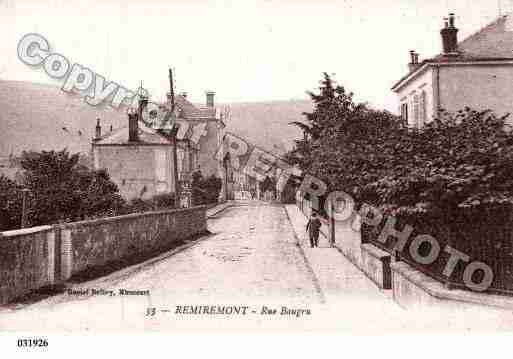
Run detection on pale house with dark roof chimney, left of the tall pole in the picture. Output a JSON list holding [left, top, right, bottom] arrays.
[[92, 113, 175, 199]]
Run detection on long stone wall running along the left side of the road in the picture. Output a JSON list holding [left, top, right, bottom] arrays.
[[0, 206, 207, 305]]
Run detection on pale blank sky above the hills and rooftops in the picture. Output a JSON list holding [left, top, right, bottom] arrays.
[[0, 0, 513, 112]]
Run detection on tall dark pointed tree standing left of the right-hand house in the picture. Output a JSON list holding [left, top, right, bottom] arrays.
[[286, 73, 404, 202]]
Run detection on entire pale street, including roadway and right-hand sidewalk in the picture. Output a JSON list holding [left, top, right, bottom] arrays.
[[0, 201, 509, 332]]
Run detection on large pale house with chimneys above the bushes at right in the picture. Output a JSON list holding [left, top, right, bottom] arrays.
[[392, 14, 513, 128]]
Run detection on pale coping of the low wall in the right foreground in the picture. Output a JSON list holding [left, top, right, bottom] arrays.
[[390, 262, 513, 310]]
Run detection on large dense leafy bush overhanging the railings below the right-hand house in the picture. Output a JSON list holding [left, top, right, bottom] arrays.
[[362, 108, 513, 221]]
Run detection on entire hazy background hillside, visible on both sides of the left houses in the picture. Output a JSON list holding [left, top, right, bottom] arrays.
[[0, 81, 312, 157]]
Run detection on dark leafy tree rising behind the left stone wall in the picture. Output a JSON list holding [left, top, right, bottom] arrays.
[[20, 150, 124, 225]]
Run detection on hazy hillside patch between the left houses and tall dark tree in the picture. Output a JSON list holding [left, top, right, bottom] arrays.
[[226, 100, 312, 155]]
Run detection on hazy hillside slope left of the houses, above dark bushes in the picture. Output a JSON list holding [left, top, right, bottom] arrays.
[[0, 81, 126, 155]]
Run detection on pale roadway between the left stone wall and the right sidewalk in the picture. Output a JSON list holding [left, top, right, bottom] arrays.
[[0, 202, 322, 330]]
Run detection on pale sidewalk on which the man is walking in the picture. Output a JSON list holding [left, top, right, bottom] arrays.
[[285, 204, 396, 307]]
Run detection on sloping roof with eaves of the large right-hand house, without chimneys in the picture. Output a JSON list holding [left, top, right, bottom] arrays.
[[392, 14, 513, 90]]
